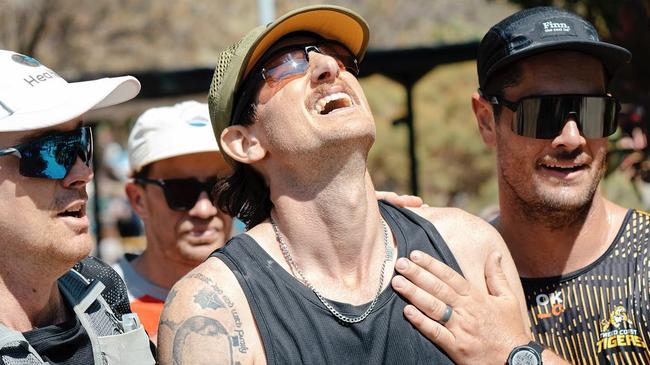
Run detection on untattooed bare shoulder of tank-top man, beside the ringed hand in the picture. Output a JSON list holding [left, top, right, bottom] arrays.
[[412, 207, 519, 290]]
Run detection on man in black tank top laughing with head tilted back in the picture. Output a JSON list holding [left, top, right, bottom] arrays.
[[159, 6, 529, 364]]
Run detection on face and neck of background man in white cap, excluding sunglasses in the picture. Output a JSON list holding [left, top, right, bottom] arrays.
[[126, 152, 232, 288]]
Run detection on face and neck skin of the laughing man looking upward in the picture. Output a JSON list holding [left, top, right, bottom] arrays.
[[238, 37, 390, 304]]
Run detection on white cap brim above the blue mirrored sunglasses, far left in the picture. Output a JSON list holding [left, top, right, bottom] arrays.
[[0, 76, 140, 132]]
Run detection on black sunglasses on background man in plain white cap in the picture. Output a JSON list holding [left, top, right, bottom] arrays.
[[134, 176, 219, 211]]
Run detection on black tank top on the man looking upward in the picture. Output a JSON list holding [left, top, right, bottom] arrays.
[[211, 202, 460, 365]]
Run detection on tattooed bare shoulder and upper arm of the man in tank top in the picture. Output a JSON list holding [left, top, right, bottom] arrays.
[[158, 258, 265, 365]]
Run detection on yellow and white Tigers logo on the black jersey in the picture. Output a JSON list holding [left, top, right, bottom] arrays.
[[598, 305, 647, 353]]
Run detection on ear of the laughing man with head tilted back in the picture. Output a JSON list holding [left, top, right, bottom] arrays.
[[221, 125, 266, 165]]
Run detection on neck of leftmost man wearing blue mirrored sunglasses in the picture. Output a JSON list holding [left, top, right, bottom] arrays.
[[0, 264, 69, 332]]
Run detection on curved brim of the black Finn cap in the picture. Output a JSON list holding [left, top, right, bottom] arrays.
[[484, 42, 632, 83]]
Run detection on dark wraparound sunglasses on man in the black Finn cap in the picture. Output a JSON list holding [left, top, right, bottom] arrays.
[[485, 95, 621, 139]]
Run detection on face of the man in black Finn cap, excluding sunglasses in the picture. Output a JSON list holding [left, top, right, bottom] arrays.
[[496, 54, 607, 219]]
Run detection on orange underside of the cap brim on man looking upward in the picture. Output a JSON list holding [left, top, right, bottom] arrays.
[[242, 5, 369, 78]]
